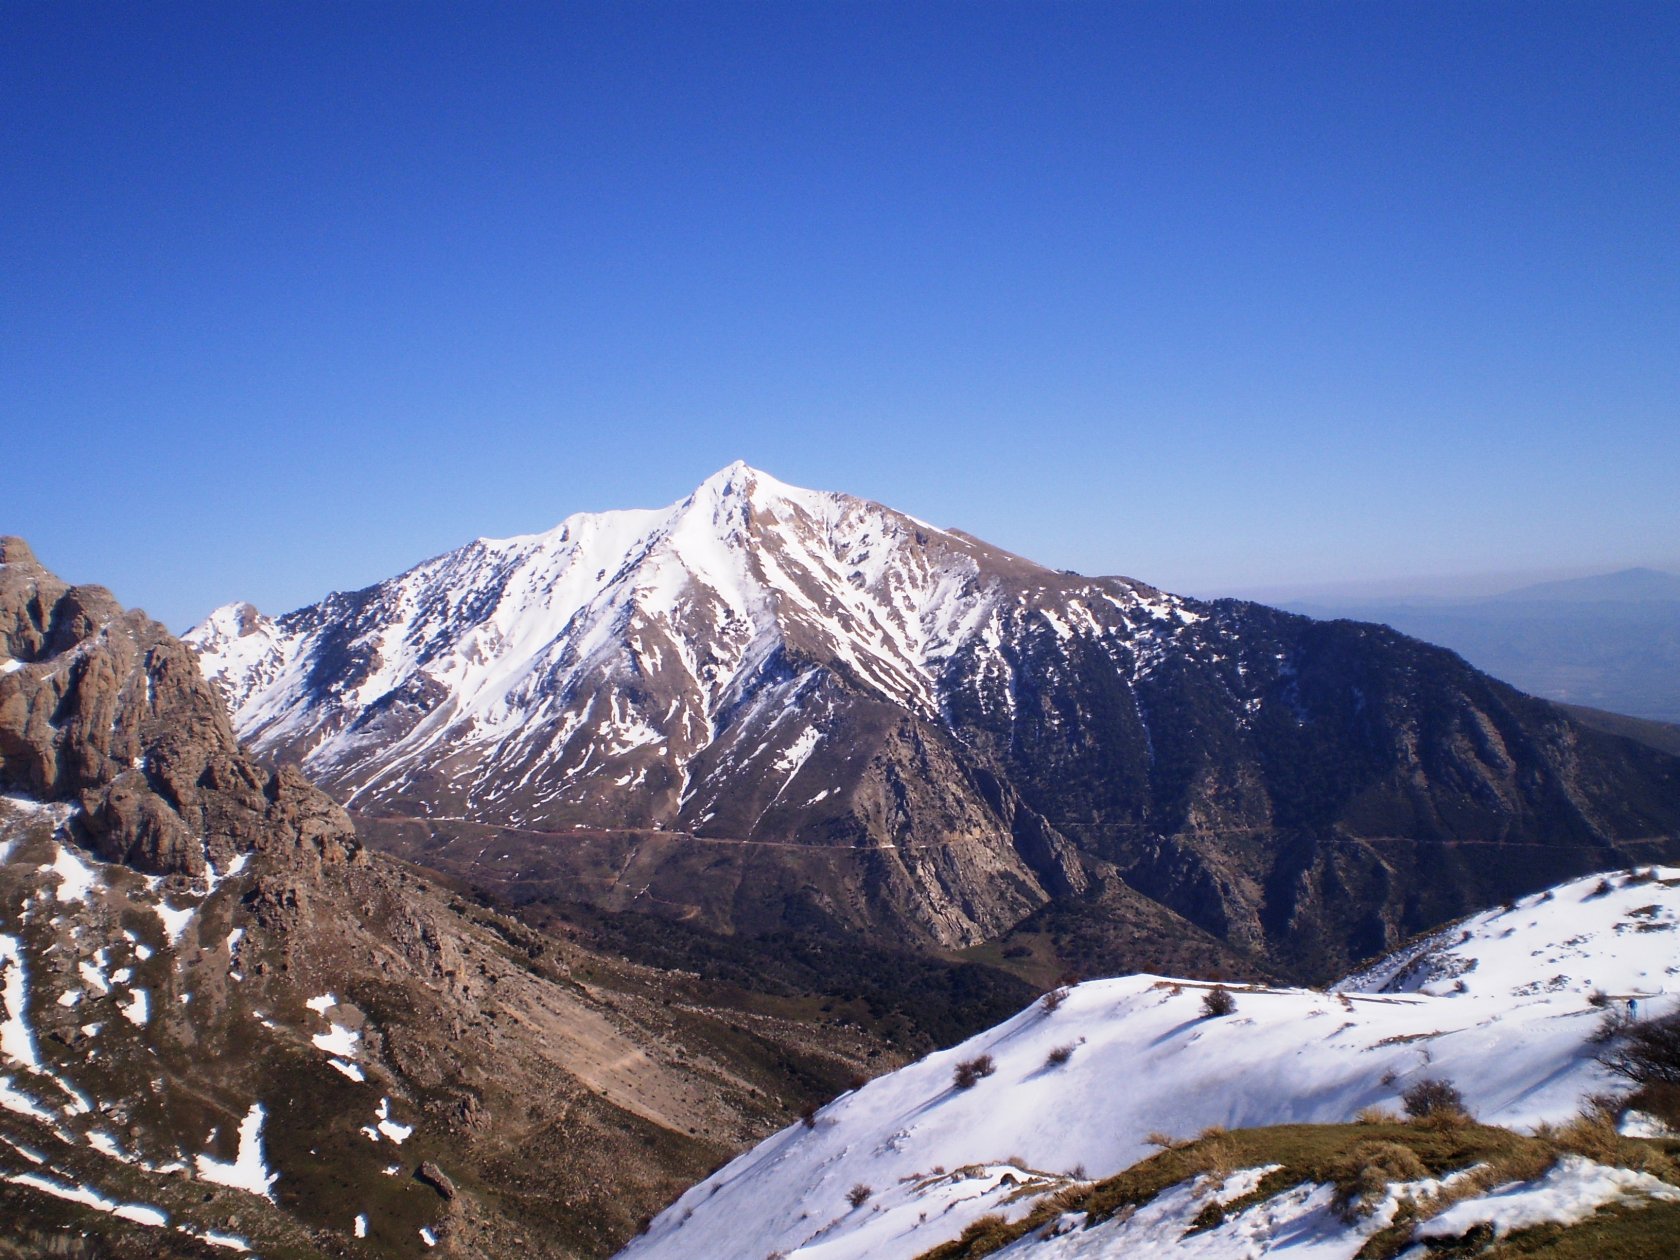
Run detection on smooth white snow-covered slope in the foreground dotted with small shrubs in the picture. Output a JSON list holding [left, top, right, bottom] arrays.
[[623, 867, 1680, 1260]]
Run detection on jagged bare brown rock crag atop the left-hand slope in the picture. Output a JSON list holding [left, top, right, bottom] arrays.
[[0, 538, 360, 879]]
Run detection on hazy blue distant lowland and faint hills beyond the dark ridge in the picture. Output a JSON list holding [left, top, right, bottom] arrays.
[[1287, 568, 1680, 722]]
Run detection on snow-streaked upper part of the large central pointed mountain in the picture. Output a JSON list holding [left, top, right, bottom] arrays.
[[188, 462, 1102, 850]]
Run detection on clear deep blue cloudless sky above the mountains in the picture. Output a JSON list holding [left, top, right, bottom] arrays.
[[0, 0, 1680, 628]]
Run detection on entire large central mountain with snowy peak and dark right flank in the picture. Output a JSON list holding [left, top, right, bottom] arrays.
[[190, 465, 1680, 976]]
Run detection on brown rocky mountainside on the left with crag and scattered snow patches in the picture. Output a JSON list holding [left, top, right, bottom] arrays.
[[0, 539, 897, 1258]]
